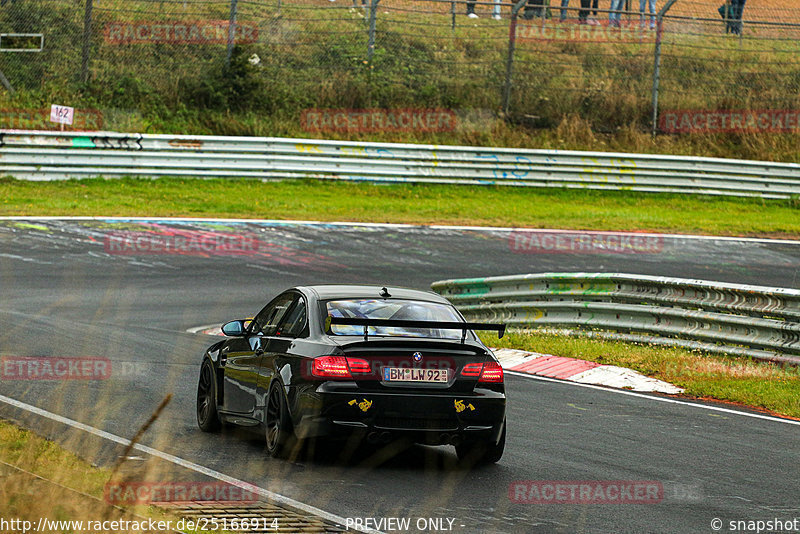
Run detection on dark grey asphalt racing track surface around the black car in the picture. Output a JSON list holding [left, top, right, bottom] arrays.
[[0, 220, 800, 533]]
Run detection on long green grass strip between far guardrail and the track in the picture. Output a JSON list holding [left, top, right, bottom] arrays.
[[0, 178, 800, 236]]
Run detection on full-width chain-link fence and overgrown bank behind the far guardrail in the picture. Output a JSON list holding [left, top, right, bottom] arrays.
[[0, 0, 800, 133]]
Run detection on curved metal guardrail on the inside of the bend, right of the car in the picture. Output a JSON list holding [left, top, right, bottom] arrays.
[[431, 273, 800, 365]]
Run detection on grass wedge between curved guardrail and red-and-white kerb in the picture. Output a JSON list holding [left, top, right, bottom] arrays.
[[481, 332, 800, 418]]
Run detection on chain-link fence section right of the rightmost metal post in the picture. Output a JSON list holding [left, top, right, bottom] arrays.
[[656, 0, 800, 136]]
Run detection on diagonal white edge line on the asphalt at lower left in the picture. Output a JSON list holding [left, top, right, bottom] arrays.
[[0, 395, 383, 534]]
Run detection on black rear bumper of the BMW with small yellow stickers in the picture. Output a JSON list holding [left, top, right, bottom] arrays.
[[294, 383, 506, 444]]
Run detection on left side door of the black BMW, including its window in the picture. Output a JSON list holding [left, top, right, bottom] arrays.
[[223, 293, 295, 414]]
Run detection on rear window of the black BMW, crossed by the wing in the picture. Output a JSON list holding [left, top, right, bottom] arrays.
[[326, 299, 462, 339]]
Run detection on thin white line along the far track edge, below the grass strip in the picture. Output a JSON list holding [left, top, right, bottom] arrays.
[[0, 215, 800, 245]]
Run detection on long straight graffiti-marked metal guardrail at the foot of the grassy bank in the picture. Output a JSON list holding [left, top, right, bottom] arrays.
[[0, 130, 800, 198]]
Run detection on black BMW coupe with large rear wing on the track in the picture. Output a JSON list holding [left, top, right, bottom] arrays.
[[197, 285, 506, 463]]
